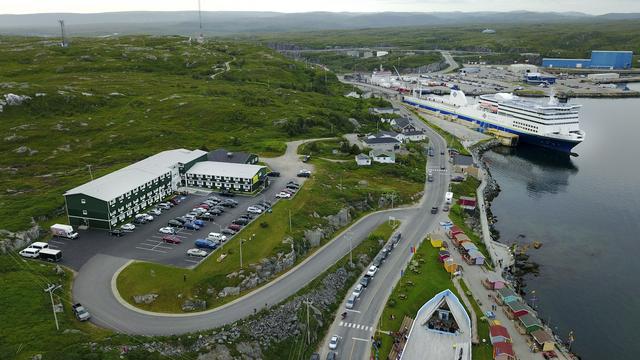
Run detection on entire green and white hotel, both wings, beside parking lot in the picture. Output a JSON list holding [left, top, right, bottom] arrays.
[[64, 149, 267, 229]]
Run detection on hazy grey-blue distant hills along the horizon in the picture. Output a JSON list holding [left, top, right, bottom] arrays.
[[0, 11, 640, 36]]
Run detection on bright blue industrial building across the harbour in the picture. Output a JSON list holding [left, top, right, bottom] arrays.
[[542, 50, 633, 70]]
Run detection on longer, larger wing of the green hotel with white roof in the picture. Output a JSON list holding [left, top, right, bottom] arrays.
[[64, 149, 207, 229]]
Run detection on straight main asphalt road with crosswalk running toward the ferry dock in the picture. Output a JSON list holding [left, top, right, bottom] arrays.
[[320, 97, 449, 360]]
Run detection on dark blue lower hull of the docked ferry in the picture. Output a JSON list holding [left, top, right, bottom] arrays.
[[403, 98, 580, 153]]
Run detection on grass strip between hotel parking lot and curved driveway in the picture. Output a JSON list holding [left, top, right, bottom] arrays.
[[117, 154, 424, 312]]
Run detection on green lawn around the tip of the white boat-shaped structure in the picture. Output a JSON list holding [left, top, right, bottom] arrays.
[[372, 240, 492, 360]]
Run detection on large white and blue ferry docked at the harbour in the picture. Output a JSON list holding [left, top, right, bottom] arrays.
[[403, 90, 585, 152]]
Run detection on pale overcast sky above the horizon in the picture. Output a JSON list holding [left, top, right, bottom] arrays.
[[0, 0, 640, 14]]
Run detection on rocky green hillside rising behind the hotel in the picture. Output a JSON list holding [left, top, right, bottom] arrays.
[[0, 36, 390, 231]]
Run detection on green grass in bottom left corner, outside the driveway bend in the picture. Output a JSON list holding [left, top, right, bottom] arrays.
[[0, 253, 121, 360]]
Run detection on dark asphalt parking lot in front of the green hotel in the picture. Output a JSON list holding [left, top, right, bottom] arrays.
[[49, 172, 303, 270]]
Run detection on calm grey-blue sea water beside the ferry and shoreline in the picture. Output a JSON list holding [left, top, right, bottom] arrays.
[[484, 90, 640, 360]]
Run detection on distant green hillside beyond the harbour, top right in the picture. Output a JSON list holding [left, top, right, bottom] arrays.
[[261, 20, 640, 66]]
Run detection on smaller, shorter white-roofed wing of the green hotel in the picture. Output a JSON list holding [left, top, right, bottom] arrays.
[[185, 161, 267, 193]]
